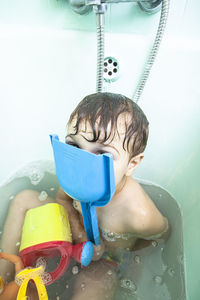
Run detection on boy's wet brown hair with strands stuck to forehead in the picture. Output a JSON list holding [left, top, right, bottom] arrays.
[[68, 93, 149, 158]]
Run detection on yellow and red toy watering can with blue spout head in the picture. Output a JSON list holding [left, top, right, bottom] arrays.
[[19, 203, 93, 285]]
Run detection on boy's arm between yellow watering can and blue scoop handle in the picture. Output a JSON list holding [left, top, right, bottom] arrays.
[[56, 187, 87, 244]]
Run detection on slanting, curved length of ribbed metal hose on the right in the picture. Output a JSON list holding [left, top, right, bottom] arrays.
[[133, 0, 170, 103]]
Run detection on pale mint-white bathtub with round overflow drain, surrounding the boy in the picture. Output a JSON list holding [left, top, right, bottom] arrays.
[[0, 0, 200, 300]]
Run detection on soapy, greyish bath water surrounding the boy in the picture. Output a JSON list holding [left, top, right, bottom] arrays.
[[0, 161, 186, 300]]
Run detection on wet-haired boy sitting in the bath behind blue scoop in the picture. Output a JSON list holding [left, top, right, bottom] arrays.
[[2, 93, 168, 300]]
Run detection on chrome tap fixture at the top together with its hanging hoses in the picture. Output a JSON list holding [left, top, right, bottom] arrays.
[[70, 0, 170, 98]]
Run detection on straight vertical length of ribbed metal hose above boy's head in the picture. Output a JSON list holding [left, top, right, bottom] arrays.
[[95, 4, 105, 93]]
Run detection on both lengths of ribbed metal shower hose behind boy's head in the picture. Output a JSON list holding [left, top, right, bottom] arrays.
[[96, 0, 170, 103]]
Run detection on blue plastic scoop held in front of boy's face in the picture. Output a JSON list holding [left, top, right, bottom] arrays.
[[50, 135, 115, 245]]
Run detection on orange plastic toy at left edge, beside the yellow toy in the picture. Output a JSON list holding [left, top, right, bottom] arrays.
[[0, 252, 24, 300]]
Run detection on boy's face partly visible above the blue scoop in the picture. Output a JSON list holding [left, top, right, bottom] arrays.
[[66, 115, 142, 192]]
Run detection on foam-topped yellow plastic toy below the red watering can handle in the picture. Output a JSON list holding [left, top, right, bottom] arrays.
[[15, 266, 48, 300]]
